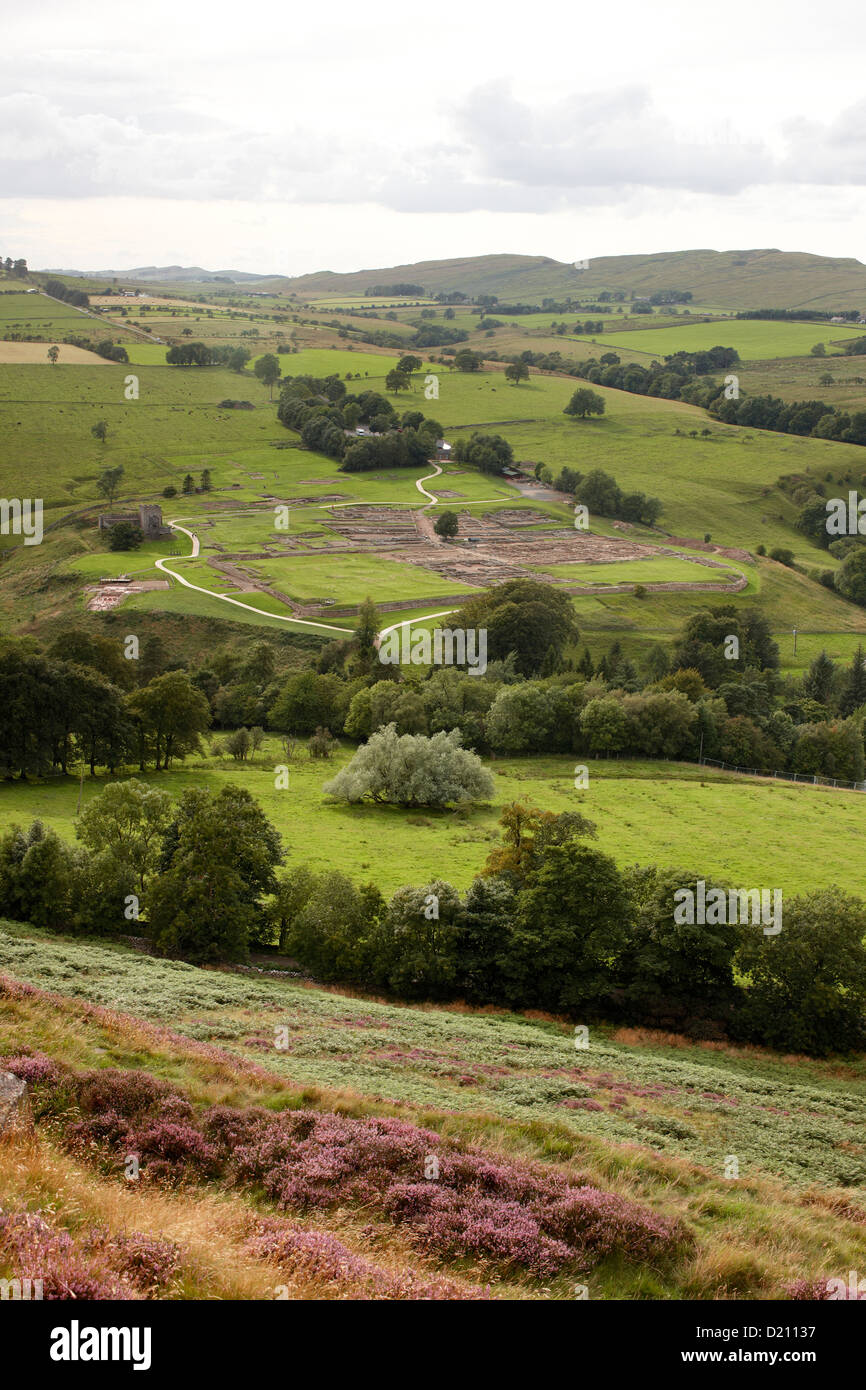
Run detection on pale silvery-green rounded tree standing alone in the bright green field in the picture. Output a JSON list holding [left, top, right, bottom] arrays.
[[322, 724, 493, 806]]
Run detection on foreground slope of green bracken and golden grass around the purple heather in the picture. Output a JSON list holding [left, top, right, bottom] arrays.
[[0, 924, 866, 1298]]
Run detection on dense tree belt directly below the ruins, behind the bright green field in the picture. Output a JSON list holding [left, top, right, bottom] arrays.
[[0, 580, 866, 801]]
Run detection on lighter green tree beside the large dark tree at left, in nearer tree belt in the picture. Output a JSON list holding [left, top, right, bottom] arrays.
[[75, 777, 172, 894]]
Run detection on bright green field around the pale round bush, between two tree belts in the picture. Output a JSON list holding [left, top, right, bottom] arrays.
[[0, 745, 866, 895]]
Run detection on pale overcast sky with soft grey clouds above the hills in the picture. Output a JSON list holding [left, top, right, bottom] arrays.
[[0, 0, 866, 275]]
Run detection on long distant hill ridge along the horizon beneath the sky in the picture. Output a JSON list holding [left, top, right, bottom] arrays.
[[38, 250, 866, 309]]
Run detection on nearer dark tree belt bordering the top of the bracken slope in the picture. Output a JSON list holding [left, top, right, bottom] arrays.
[[0, 781, 866, 1056]]
